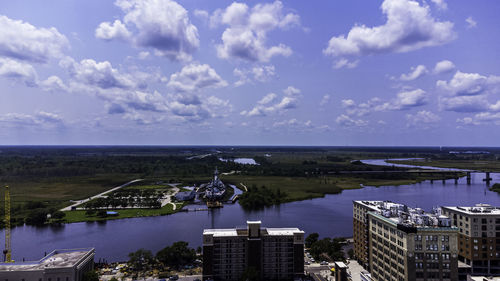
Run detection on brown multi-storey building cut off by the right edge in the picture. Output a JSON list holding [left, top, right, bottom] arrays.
[[442, 204, 500, 276]]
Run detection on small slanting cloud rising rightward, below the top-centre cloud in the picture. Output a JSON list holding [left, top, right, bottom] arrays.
[[240, 86, 300, 117]]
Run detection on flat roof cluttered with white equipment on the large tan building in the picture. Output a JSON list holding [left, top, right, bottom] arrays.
[[356, 201, 451, 228]]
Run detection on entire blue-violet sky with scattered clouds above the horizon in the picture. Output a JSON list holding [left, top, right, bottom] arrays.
[[0, 0, 500, 146]]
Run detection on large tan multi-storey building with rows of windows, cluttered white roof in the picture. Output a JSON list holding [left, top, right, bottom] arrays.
[[353, 201, 458, 281]]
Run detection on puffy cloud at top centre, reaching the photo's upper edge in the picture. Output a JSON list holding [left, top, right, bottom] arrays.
[[210, 1, 300, 62]]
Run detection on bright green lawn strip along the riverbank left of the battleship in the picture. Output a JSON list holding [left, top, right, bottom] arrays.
[[63, 203, 184, 223]]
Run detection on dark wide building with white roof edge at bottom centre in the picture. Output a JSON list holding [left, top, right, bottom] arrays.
[[203, 221, 304, 281]]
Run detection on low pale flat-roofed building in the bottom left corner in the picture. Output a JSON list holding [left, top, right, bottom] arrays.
[[0, 248, 95, 281]]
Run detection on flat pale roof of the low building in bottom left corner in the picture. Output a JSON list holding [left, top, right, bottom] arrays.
[[0, 248, 95, 271]]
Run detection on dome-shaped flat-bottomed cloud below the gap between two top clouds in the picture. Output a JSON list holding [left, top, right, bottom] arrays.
[[168, 63, 227, 92]]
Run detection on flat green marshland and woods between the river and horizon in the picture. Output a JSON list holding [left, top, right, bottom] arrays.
[[0, 146, 500, 224]]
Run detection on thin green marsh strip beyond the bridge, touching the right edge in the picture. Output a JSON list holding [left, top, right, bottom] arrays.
[[388, 160, 500, 172]]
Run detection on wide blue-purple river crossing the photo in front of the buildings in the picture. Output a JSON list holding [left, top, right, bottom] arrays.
[[0, 173, 500, 261]]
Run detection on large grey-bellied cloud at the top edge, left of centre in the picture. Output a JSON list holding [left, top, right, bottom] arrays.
[[95, 0, 199, 60]]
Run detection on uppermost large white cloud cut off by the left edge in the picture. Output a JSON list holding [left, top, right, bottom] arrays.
[[0, 15, 69, 63]]
